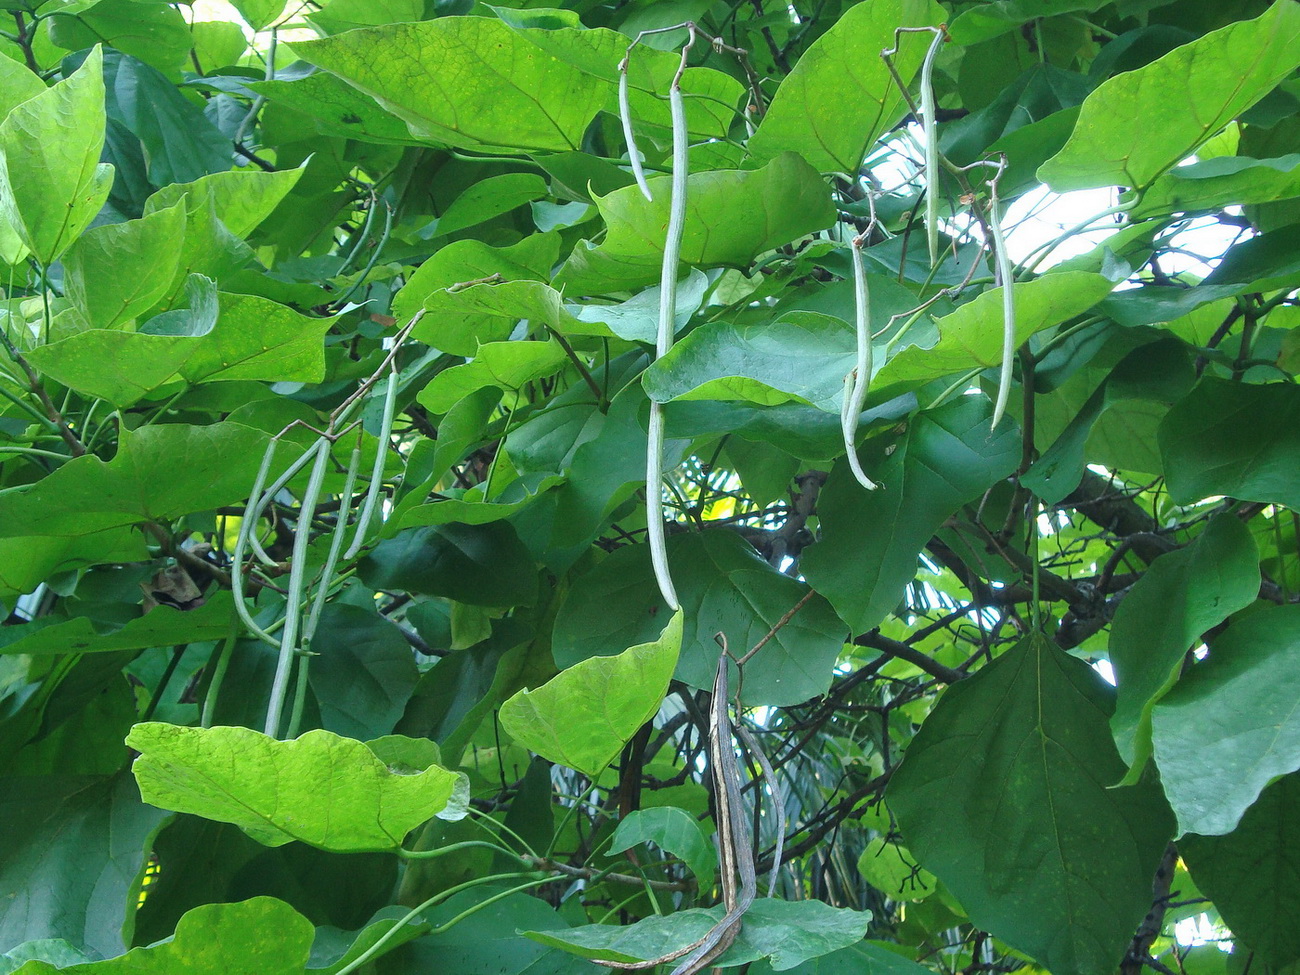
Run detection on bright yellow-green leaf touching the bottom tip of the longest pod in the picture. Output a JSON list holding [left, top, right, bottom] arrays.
[[501, 611, 683, 779]]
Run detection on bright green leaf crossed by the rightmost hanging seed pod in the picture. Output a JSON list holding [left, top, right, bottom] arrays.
[[872, 270, 1115, 397]]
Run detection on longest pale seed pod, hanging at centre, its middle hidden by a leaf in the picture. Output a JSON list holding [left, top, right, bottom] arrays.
[[646, 70, 689, 611]]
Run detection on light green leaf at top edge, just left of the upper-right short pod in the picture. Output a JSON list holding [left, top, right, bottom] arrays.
[[749, 0, 946, 173]]
